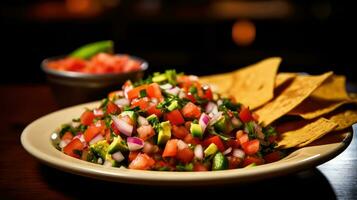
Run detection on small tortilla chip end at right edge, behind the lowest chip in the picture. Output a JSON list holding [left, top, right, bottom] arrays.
[[329, 110, 357, 130]]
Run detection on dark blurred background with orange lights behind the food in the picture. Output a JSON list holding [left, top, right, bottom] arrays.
[[0, 0, 356, 84]]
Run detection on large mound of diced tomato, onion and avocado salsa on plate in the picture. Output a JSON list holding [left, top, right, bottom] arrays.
[[57, 70, 283, 171]]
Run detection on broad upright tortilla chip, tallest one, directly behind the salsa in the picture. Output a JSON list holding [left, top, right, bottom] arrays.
[[230, 57, 281, 109]]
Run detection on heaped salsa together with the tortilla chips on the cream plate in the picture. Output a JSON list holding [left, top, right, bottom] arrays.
[[51, 58, 357, 171]]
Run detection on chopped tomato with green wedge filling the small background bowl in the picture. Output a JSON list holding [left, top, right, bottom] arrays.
[[47, 41, 142, 74]]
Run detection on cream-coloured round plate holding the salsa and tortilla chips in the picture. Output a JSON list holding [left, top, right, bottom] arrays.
[[21, 102, 353, 185]]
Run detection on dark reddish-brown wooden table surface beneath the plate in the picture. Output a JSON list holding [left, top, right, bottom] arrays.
[[0, 85, 357, 200]]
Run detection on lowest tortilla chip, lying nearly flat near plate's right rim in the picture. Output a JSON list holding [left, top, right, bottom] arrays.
[[277, 118, 337, 149]]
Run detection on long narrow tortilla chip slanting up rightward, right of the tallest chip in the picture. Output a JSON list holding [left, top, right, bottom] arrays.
[[256, 72, 333, 125]]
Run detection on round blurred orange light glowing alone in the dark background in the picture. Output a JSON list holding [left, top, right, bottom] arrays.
[[232, 20, 256, 46]]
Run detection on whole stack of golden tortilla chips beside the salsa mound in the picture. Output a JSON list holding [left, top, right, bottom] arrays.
[[200, 57, 357, 148]]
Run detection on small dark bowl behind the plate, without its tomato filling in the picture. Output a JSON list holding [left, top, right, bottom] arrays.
[[41, 56, 149, 107]]
